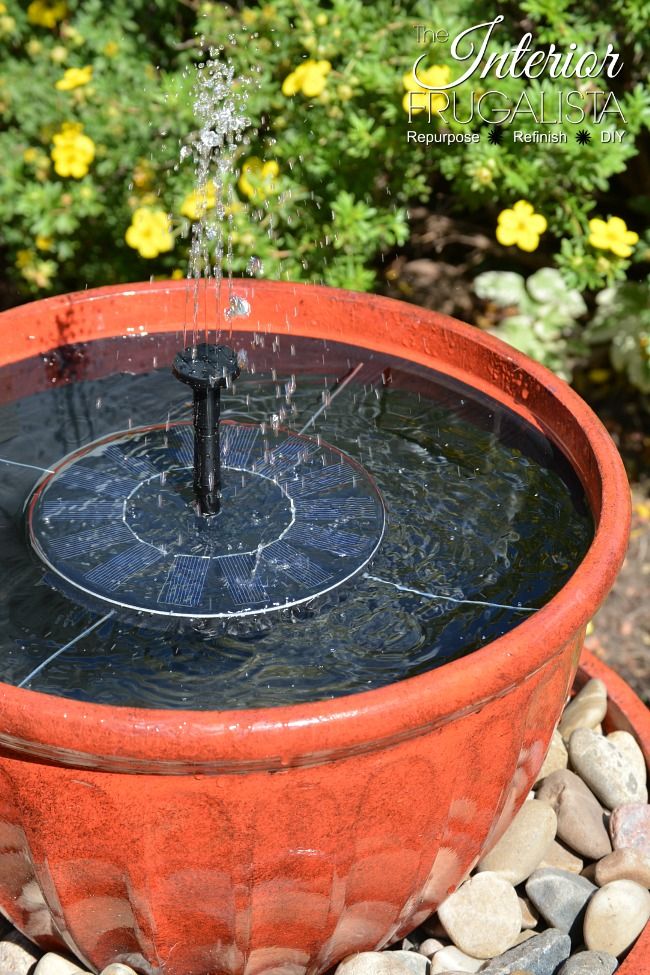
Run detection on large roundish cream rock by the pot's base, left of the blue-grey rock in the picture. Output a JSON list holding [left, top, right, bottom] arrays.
[[438, 871, 521, 958]]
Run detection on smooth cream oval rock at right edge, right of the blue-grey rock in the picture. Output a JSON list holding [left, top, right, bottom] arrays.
[[583, 880, 650, 958]]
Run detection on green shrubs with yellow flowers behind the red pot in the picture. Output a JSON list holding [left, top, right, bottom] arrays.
[[0, 0, 650, 400]]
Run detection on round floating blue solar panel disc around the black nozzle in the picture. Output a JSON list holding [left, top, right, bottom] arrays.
[[27, 420, 385, 619]]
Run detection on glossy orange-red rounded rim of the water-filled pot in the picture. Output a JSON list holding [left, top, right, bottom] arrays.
[[0, 281, 630, 774]]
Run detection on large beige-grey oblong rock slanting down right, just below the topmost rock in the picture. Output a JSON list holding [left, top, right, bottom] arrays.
[[569, 728, 648, 809]]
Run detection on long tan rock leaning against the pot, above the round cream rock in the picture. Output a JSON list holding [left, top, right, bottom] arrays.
[[476, 799, 557, 886]]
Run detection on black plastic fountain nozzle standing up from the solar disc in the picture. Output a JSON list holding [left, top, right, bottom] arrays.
[[172, 342, 240, 515]]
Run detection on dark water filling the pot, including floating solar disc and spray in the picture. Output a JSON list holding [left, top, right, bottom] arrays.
[[0, 57, 592, 709]]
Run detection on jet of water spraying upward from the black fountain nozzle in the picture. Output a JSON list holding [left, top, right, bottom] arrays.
[[180, 49, 250, 345]]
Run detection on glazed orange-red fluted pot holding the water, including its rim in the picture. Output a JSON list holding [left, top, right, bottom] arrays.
[[0, 282, 629, 975]]
